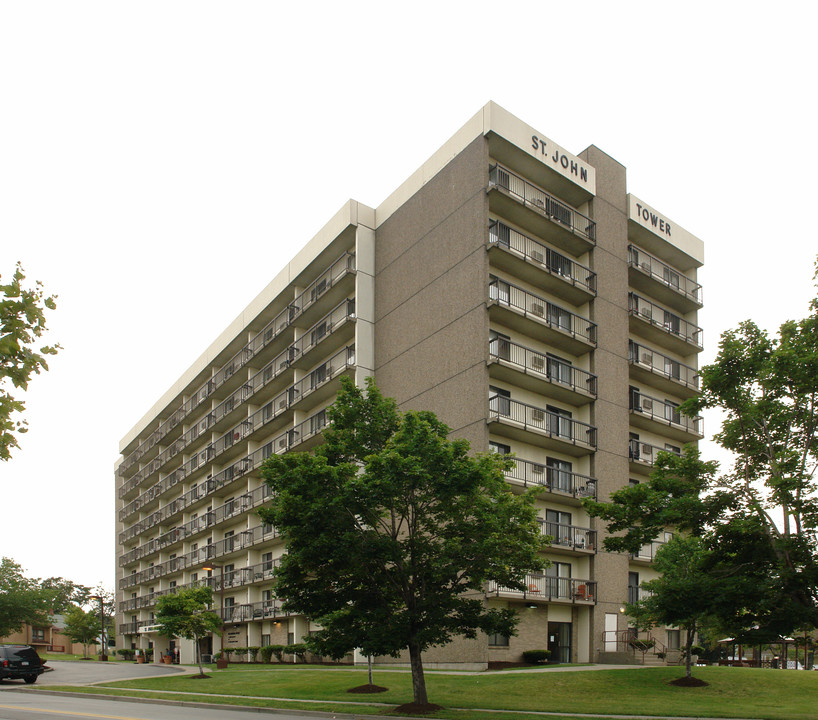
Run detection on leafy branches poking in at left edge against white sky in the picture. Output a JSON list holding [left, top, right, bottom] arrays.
[[0, 263, 60, 460]]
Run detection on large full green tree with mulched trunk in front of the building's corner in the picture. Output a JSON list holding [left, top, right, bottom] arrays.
[[260, 377, 543, 707]]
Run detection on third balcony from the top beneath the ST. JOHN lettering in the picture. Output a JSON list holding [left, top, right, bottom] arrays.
[[488, 279, 596, 355]]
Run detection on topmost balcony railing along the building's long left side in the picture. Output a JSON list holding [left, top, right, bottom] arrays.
[[117, 252, 355, 484]]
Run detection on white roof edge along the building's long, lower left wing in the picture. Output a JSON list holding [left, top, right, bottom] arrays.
[[119, 200, 375, 452]]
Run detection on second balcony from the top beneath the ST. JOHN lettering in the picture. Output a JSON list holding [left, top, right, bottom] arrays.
[[489, 220, 596, 305]]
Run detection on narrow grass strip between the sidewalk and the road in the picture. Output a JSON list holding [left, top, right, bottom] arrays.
[[35, 685, 636, 720]]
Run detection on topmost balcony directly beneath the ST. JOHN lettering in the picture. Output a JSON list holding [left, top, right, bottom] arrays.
[[488, 165, 596, 256]]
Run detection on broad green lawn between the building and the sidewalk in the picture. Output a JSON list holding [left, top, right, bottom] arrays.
[[43, 665, 818, 720]]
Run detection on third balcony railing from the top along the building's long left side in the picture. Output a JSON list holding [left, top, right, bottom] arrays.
[[119, 346, 355, 520]]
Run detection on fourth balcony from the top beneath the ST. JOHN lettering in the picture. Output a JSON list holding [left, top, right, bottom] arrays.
[[489, 338, 596, 405]]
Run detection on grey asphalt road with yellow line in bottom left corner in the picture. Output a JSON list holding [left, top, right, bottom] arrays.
[[0, 684, 342, 720]]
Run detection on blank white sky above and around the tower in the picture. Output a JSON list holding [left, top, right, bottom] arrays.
[[0, 0, 818, 587]]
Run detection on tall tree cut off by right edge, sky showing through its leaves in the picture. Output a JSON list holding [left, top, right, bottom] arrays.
[[682, 263, 818, 635]]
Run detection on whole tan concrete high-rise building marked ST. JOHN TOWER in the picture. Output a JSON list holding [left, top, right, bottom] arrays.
[[115, 103, 703, 668]]
